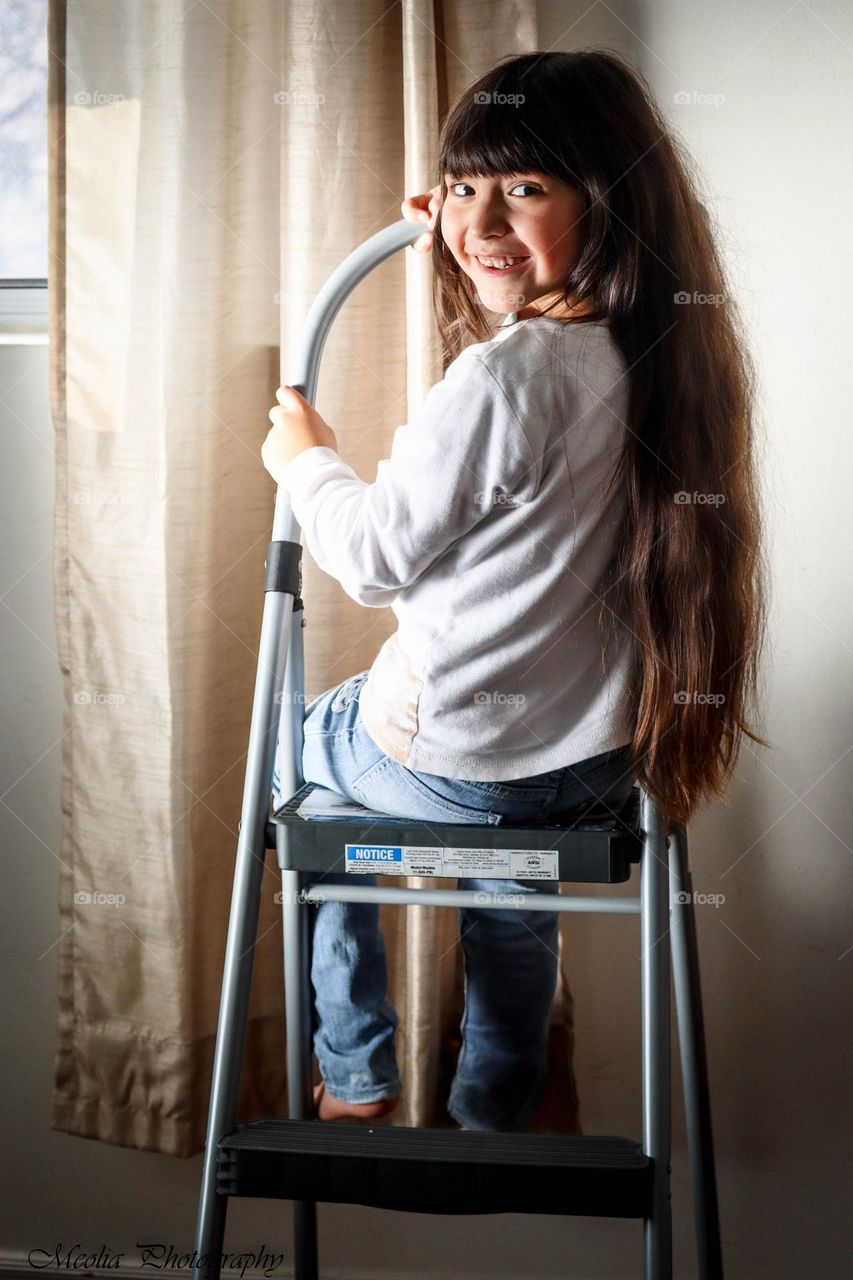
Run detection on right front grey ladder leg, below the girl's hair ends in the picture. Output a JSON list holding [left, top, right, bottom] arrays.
[[640, 791, 672, 1280]]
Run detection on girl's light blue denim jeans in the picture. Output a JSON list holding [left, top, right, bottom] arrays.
[[273, 671, 634, 1132]]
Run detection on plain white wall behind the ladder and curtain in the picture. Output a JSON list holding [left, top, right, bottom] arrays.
[[0, 0, 853, 1280]]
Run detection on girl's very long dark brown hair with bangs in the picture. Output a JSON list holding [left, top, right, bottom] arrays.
[[433, 49, 771, 824]]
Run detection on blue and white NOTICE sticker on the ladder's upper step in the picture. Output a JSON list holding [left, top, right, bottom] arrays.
[[345, 845, 558, 879]]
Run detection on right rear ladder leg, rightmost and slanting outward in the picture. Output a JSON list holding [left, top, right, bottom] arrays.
[[670, 826, 722, 1280]]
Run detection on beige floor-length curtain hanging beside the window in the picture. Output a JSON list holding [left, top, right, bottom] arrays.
[[49, 0, 576, 1156]]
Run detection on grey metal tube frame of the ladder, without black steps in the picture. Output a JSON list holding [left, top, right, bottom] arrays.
[[193, 220, 722, 1280]]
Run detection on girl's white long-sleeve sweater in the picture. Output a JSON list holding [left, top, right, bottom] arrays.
[[280, 316, 634, 781]]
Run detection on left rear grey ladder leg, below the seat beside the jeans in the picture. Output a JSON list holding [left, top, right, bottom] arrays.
[[282, 870, 318, 1280]]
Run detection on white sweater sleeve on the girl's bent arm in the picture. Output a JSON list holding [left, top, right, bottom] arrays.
[[280, 352, 538, 608]]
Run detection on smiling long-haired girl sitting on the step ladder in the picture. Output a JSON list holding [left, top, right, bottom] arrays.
[[263, 50, 768, 1130]]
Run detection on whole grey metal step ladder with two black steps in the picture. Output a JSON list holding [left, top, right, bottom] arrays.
[[193, 221, 722, 1280]]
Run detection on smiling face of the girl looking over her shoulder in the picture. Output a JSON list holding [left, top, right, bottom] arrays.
[[441, 172, 584, 316]]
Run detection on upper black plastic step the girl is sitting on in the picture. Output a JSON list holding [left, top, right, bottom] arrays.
[[265, 782, 642, 884]]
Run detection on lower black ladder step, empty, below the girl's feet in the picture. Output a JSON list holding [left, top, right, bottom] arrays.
[[216, 1117, 653, 1217]]
